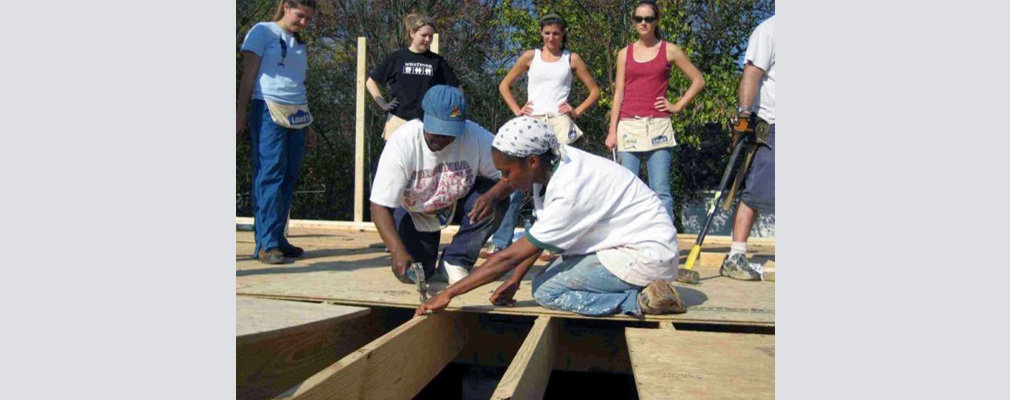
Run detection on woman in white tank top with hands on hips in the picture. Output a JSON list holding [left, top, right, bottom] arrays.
[[498, 13, 600, 144]]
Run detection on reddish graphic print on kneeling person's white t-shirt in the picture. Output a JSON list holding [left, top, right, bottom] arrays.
[[403, 161, 477, 213]]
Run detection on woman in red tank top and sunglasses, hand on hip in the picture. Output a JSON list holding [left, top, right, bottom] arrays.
[[606, 0, 705, 219]]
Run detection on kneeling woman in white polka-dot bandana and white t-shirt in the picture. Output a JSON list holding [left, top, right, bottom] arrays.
[[416, 116, 686, 315]]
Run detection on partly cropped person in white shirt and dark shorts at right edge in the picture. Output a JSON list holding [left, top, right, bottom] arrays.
[[719, 15, 775, 281]]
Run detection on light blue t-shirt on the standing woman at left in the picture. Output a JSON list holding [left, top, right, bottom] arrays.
[[242, 22, 308, 104]]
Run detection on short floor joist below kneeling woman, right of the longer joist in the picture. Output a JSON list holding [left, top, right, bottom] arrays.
[[491, 315, 561, 399]]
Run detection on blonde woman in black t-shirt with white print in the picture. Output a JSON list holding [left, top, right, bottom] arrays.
[[365, 13, 460, 140]]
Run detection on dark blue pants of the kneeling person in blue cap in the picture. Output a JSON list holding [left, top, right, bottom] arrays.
[[393, 177, 508, 279]]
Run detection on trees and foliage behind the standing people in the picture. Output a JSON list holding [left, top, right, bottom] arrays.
[[235, 0, 775, 231]]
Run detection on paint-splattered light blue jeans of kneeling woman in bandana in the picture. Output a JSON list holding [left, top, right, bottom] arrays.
[[533, 254, 642, 315]]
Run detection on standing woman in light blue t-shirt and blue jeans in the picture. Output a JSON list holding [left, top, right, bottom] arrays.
[[235, 0, 316, 264]]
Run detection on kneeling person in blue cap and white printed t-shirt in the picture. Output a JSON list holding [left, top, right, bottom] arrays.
[[370, 85, 512, 284]]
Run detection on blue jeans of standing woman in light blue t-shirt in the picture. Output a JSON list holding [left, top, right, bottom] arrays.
[[249, 100, 305, 259]]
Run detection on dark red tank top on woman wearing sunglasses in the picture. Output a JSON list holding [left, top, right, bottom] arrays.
[[620, 40, 670, 118]]
